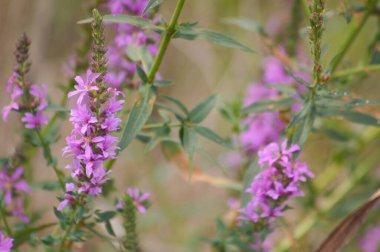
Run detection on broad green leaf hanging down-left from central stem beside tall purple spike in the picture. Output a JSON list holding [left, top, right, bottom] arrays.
[[119, 86, 156, 150]]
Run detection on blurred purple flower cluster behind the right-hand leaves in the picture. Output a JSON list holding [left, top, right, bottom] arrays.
[[240, 54, 307, 154]]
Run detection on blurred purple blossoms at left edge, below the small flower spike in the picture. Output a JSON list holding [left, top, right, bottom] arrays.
[[0, 167, 30, 222]]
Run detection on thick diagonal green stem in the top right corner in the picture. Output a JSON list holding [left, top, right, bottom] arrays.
[[331, 0, 377, 74]]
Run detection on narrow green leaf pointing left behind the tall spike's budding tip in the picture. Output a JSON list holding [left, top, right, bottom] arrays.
[[78, 15, 165, 32]]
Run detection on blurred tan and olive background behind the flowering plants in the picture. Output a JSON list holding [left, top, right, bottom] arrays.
[[0, 0, 380, 252]]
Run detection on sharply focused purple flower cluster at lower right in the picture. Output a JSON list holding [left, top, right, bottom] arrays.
[[239, 140, 314, 224]]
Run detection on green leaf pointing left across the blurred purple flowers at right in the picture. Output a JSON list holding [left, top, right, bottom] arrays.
[[242, 97, 295, 116]]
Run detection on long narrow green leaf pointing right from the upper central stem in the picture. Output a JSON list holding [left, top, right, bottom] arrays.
[[173, 26, 254, 53]]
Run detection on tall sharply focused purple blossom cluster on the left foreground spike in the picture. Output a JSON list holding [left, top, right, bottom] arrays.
[[57, 70, 124, 210]]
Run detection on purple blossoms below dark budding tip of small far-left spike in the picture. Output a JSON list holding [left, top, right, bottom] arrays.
[[2, 71, 48, 129]]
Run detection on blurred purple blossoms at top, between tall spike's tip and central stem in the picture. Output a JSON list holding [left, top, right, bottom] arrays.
[[107, 0, 159, 89]]
